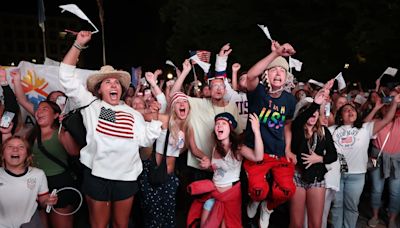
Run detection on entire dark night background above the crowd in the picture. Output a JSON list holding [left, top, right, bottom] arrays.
[[1, 0, 400, 87]]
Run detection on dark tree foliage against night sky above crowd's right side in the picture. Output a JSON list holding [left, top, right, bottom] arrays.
[[160, 0, 400, 87]]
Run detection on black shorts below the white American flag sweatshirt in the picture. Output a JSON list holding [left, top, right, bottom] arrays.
[[82, 167, 139, 201]]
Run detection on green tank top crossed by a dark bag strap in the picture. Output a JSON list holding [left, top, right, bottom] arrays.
[[32, 130, 68, 176]]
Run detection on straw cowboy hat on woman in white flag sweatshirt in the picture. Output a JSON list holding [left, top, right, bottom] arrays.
[[86, 65, 131, 93]]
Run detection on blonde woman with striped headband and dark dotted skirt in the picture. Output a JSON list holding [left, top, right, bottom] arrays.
[[140, 89, 190, 227]]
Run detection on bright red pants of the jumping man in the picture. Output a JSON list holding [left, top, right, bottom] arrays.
[[243, 154, 296, 210]]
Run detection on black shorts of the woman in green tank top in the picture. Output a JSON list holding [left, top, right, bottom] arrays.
[[47, 171, 79, 208]]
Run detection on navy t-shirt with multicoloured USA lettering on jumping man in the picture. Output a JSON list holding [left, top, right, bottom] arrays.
[[245, 84, 296, 157]]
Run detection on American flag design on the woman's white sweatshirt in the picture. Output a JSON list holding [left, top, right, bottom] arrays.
[[96, 107, 135, 139]]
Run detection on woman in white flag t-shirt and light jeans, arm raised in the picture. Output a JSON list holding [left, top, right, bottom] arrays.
[[329, 91, 400, 228]]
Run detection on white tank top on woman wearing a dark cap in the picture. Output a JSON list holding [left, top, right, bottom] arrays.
[[211, 151, 242, 187]]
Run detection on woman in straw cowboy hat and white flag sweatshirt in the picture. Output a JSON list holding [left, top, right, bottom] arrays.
[[60, 31, 166, 227]]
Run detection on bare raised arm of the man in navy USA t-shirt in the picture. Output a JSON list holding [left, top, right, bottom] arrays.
[[247, 41, 296, 91]]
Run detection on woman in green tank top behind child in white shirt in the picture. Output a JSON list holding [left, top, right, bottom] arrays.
[[28, 100, 79, 228]]
